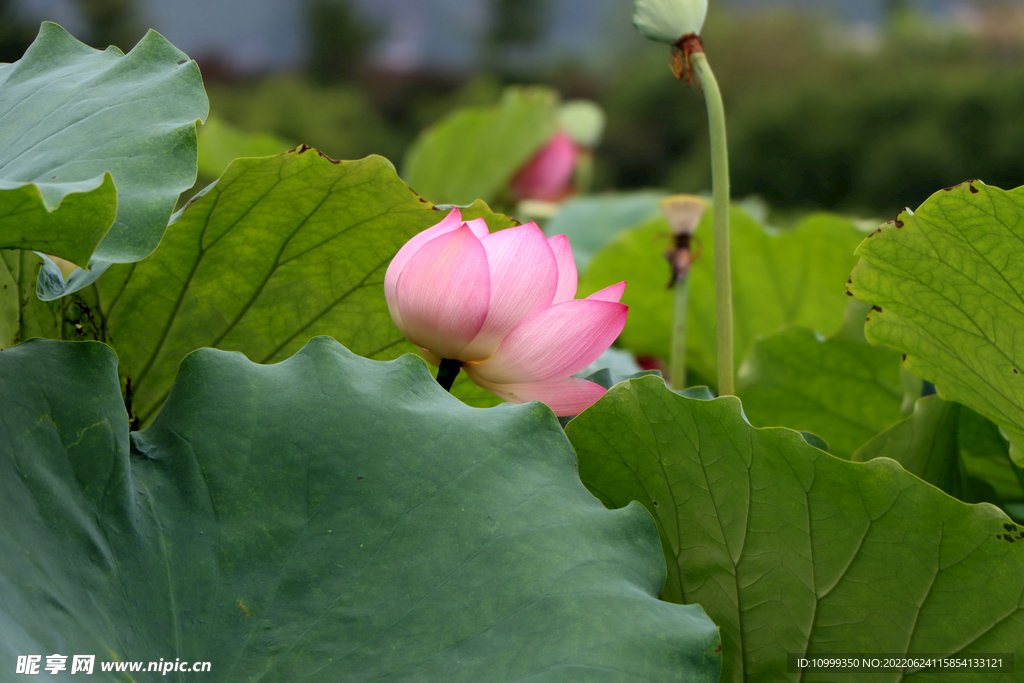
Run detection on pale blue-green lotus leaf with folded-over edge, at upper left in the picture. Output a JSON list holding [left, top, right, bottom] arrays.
[[0, 23, 209, 290]]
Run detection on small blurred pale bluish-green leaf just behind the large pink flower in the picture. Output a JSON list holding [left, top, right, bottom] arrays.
[[544, 189, 668, 272]]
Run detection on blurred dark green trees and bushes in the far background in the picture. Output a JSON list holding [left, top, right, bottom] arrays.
[[0, 0, 1024, 217]]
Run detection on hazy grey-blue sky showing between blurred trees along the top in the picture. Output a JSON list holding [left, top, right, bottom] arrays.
[[19, 0, 955, 72]]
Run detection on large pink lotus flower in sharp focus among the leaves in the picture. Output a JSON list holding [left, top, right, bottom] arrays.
[[384, 209, 627, 415]]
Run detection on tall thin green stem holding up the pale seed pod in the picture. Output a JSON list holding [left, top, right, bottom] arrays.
[[689, 52, 736, 396]]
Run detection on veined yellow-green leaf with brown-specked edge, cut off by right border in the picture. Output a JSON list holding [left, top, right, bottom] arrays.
[[849, 180, 1024, 466]]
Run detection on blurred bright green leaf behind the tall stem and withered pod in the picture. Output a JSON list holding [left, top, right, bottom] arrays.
[[580, 206, 863, 381]]
